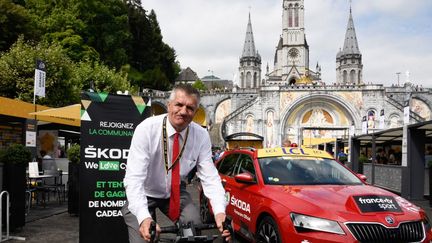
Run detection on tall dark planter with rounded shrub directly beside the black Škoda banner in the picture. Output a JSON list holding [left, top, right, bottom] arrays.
[[67, 144, 81, 215]]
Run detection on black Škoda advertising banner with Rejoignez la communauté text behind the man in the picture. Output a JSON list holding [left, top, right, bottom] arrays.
[[79, 92, 151, 243]]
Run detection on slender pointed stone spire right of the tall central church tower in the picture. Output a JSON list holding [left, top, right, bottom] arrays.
[[336, 6, 363, 84]]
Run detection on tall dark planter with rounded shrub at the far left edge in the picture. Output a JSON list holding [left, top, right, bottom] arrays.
[[0, 144, 31, 231]]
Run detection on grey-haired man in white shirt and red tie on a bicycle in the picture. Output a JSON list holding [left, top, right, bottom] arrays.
[[122, 85, 229, 243]]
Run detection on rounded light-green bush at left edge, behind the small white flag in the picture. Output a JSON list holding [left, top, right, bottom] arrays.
[[0, 38, 80, 106]]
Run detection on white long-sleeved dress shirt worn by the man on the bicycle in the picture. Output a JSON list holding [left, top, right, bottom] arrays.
[[124, 114, 226, 224]]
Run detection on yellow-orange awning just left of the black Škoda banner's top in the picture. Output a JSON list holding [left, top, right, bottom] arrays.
[[29, 104, 81, 127]]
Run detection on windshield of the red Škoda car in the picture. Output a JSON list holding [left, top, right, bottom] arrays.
[[258, 157, 362, 185]]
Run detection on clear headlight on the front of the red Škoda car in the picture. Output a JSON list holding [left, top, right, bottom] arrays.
[[291, 213, 345, 235]]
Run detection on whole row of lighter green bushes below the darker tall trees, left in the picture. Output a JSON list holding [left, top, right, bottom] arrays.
[[0, 38, 129, 107]]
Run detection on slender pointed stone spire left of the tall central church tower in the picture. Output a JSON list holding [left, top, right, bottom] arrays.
[[239, 13, 261, 88]]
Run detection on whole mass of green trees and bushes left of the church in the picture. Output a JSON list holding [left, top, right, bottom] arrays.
[[0, 0, 180, 98]]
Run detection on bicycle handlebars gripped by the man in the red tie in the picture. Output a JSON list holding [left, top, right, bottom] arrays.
[[150, 217, 234, 243]]
